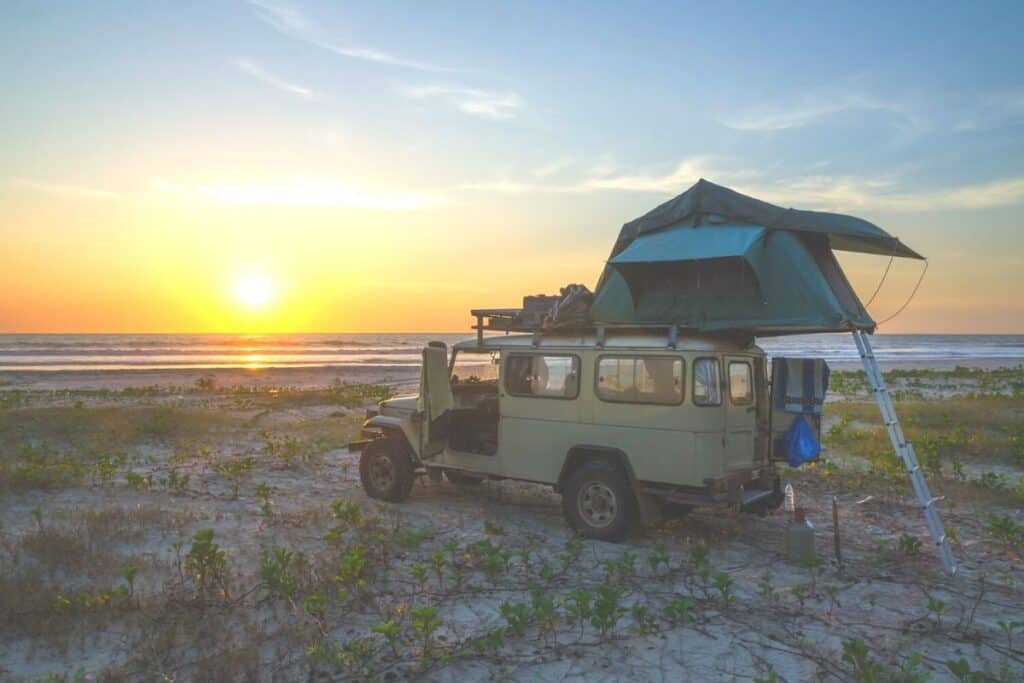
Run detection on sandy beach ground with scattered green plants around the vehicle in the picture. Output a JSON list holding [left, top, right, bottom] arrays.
[[0, 365, 1024, 681]]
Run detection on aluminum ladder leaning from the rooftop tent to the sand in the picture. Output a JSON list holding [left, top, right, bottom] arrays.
[[853, 330, 956, 577]]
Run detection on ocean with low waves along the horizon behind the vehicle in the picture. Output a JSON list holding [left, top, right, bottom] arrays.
[[0, 332, 1024, 373]]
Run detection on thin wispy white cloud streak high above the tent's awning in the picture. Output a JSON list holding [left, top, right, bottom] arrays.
[[722, 93, 923, 131]]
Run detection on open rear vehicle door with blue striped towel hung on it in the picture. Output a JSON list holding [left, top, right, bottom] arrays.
[[768, 357, 829, 461]]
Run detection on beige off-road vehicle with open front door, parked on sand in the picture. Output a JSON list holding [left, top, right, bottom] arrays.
[[351, 330, 817, 541]]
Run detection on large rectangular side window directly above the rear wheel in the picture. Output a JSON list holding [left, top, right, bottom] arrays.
[[597, 355, 683, 405]]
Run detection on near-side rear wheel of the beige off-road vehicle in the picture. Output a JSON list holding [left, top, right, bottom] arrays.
[[562, 461, 638, 543]]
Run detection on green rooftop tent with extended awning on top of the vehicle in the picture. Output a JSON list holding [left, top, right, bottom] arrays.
[[590, 179, 924, 336]]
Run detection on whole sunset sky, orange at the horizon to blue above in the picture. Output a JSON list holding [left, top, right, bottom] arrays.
[[0, 0, 1024, 333]]
